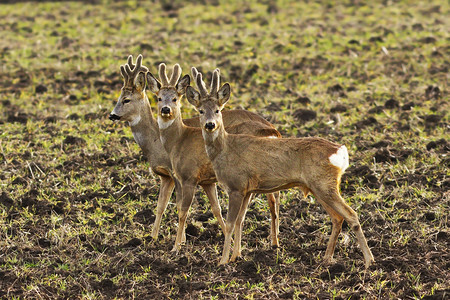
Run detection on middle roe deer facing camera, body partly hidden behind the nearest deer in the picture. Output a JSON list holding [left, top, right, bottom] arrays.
[[147, 64, 280, 251]]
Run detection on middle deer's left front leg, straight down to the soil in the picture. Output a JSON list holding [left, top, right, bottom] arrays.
[[172, 183, 196, 252]]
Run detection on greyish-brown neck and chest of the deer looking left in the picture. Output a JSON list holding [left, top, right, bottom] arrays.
[[130, 96, 170, 168]]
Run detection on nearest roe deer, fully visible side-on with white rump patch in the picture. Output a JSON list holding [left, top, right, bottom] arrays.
[[186, 70, 374, 268]]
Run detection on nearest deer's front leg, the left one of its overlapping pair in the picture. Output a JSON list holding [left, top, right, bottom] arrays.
[[219, 191, 244, 265]]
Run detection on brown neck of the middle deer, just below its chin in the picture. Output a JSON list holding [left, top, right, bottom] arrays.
[[158, 112, 186, 153]]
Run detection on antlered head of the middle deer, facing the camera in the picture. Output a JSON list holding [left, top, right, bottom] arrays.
[[147, 63, 190, 123]]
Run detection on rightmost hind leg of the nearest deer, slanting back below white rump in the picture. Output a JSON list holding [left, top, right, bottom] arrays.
[[313, 189, 375, 269]]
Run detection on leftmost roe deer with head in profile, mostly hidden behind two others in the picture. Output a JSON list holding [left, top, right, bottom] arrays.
[[109, 55, 280, 250]]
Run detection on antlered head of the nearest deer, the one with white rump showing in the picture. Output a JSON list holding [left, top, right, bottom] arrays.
[[186, 68, 231, 132]]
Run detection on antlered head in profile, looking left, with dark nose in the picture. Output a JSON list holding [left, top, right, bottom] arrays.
[[109, 54, 148, 125]]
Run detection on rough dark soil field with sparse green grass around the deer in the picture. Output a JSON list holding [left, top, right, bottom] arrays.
[[0, 0, 450, 299]]
